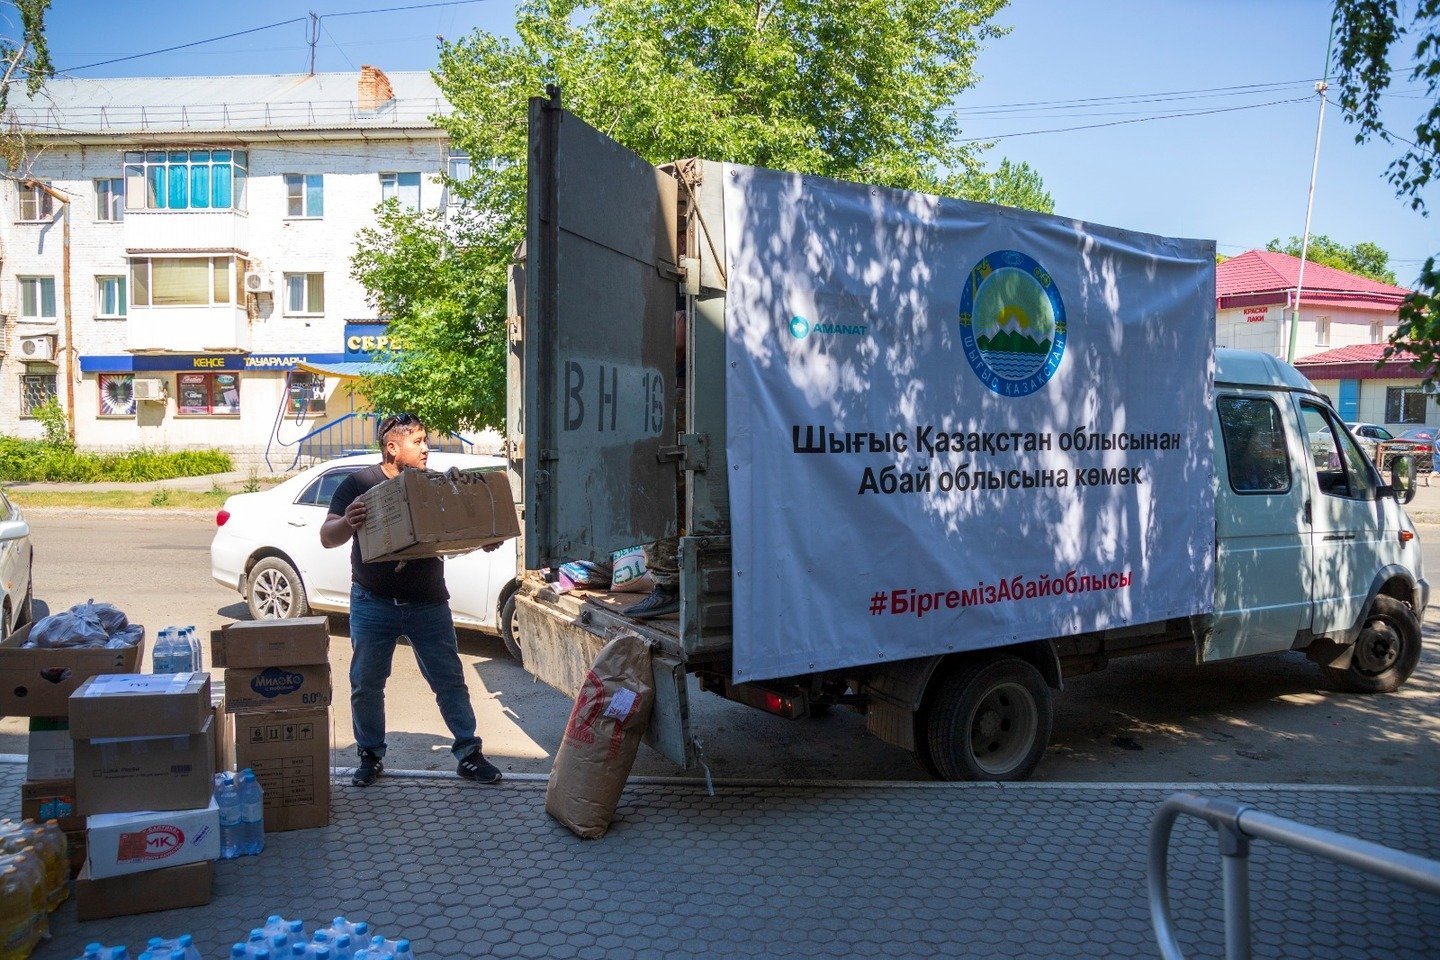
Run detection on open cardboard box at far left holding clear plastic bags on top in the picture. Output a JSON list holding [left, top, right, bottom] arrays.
[[0, 623, 145, 717]]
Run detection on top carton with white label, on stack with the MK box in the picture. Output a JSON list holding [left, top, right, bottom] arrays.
[[71, 674, 210, 740]]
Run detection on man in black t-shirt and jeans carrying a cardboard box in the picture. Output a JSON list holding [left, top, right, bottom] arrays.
[[320, 413, 501, 787]]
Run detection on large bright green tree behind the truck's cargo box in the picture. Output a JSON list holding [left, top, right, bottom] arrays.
[[353, 0, 1053, 427]]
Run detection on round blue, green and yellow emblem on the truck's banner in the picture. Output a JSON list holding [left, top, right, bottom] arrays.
[[959, 250, 1066, 397]]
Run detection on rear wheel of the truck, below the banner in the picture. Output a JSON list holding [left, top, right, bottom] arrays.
[[917, 656, 1054, 783]]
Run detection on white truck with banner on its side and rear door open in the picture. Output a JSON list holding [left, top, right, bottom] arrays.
[[501, 91, 1428, 780]]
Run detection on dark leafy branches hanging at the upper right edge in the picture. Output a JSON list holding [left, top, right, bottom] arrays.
[[1335, 0, 1440, 383]]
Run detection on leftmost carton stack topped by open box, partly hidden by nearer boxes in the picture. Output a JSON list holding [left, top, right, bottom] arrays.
[[0, 623, 145, 875]]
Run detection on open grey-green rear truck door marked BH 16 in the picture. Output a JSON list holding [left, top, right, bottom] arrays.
[[521, 95, 678, 569]]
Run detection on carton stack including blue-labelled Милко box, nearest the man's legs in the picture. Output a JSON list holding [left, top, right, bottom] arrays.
[[210, 616, 331, 833]]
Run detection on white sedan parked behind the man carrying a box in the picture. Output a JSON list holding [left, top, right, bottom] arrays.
[[210, 453, 520, 659]]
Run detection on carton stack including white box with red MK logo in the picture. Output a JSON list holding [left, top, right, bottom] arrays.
[[69, 674, 220, 920]]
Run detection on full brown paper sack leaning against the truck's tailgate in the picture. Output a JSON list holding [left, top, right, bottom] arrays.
[[544, 632, 655, 839]]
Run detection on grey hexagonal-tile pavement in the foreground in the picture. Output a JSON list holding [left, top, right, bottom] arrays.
[[14, 763, 1440, 960]]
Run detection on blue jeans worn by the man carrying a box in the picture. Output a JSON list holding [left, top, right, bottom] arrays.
[[350, 583, 480, 760]]
